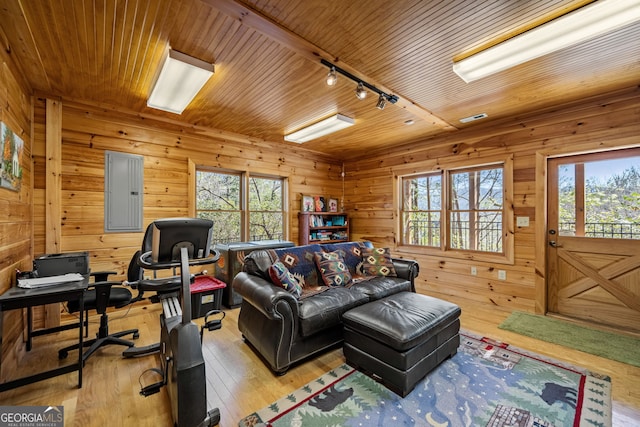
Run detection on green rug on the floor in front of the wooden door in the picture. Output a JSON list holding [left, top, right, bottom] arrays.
[[498, 311, 640, 367]]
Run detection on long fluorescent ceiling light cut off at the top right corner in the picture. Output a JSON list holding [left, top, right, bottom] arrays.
[[453, 0, 640, 83]]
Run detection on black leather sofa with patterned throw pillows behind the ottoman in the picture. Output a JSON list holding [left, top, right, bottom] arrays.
[[232, 242, 419, 374]]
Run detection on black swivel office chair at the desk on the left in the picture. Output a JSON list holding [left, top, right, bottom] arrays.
[[58, 271, 139, 364]]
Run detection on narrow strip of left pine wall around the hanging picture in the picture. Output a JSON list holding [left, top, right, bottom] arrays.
[[0, 31, 33, 376]]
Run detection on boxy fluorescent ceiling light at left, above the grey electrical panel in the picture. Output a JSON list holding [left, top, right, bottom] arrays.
[[147, 49, 214, 114]]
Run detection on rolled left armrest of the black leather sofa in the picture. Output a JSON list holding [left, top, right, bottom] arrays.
[[232, 272, 298, 320]]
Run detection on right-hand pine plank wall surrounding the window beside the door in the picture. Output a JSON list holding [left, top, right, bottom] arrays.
[[345, 87, 640, 312]]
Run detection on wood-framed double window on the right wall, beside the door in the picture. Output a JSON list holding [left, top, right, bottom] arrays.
[[400, 161, 513, 259]]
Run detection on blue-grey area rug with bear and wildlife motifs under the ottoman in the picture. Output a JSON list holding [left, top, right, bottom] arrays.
[[239, 331, 611, 427]]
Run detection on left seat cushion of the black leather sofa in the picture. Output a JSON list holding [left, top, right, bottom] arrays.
[[298, 286, 369, 337]]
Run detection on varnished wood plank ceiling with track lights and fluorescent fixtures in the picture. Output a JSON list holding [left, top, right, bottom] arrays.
[[0, 0, 640, 159]]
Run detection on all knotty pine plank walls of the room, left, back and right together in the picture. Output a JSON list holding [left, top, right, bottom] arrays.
[[0, 55, 640, 380]]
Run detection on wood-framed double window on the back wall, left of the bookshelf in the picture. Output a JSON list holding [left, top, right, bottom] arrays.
[[195, 168, 286, 243]]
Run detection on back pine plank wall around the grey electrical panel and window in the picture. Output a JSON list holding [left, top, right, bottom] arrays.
[[34, 99, 342, 279]]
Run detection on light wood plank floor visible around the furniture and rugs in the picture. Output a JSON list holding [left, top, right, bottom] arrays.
[[0, 298, 640, 427]]
